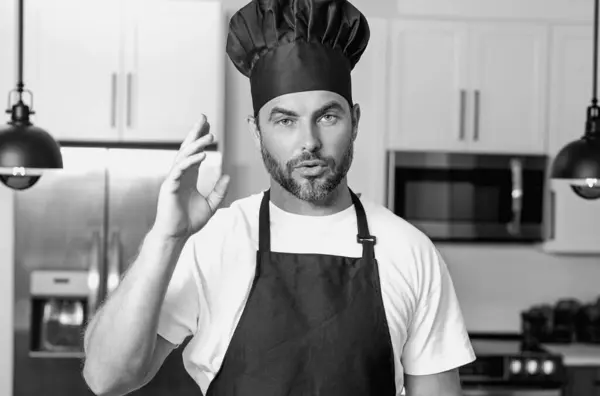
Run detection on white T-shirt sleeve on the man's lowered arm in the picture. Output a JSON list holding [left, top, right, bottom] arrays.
[[402, 244, 475, 375]]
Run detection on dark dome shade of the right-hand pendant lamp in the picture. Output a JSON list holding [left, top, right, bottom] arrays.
[[551, 136, 600, 182]]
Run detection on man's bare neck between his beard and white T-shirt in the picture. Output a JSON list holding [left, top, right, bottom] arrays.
[[270, 179, 352, 216]]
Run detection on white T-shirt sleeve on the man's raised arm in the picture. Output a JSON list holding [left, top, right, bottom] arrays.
[[158, 237, 200, 345]]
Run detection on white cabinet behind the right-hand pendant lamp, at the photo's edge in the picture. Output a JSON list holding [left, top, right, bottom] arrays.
[[544, 25, 600, 254]]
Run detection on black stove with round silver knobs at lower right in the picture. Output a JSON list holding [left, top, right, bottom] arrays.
[[459, 337, 565, 396]]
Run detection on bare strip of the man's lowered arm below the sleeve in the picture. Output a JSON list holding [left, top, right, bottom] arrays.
[[404, 369, 462, 396]]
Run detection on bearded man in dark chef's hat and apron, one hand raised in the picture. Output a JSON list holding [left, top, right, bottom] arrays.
[[84, 0, 475, 396]]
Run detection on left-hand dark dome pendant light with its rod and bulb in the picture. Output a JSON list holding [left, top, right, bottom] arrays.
[[0, 0, 63, 190]]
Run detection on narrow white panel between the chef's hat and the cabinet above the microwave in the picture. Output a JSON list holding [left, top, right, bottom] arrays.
[[348, 18, 389, 205]]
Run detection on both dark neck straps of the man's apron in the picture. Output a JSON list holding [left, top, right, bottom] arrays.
[[258, 189, 377, 259]]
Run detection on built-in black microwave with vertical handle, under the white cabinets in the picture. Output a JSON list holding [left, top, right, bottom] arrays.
[[386, 151, 547, 243]]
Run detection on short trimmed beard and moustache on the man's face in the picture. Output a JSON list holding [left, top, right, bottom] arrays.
[[260, 139, 354, 202]]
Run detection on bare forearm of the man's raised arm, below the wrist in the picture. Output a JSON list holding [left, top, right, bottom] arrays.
[[84, 231, 185, 388]]
